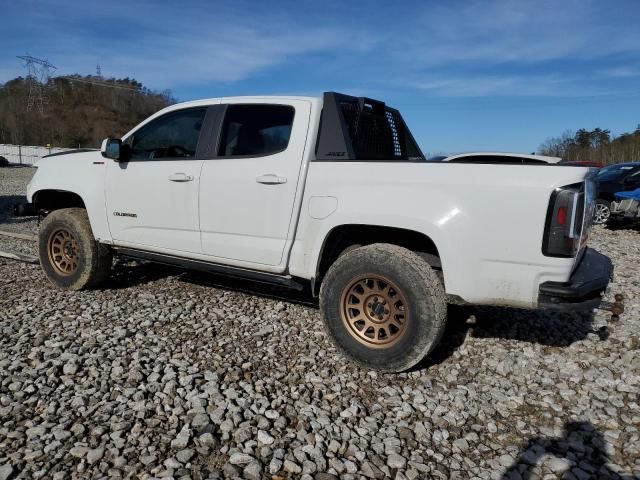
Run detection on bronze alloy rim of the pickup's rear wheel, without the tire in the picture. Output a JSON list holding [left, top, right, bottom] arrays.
[[340, 275, 409, 348]]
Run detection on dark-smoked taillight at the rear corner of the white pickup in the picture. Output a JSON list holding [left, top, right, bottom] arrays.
[[542, 184, 585, 257]]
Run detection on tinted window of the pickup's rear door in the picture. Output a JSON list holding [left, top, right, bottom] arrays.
[[218, 105, 295, 157]]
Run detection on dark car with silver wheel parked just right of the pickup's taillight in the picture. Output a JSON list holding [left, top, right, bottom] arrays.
[[593, 162, 640, 224]]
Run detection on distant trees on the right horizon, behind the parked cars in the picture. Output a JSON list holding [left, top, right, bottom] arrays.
[[538, 125, 640, 165]]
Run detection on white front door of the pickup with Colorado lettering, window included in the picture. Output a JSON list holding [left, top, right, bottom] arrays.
[[106, 108, 206, 254]]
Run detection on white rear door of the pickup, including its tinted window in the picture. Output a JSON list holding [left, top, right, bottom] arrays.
[[200, 99, 311, 271]]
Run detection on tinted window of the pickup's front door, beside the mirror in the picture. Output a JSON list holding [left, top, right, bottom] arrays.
[[127, 108, 206, 160]]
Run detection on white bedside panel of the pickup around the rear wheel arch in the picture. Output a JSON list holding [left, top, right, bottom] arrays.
[[290, 162, 588, 307]]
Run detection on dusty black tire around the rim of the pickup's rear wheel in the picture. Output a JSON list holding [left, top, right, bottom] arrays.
[[320, 243, 447, 372]]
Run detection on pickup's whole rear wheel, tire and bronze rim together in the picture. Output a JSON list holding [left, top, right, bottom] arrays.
[[320, 244, 447, 372]]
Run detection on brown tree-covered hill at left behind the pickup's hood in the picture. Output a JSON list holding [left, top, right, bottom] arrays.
[[0, 75, 175, 148]]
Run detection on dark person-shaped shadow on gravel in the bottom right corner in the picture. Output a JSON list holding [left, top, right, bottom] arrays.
[[501, 422, 638, 480]]
